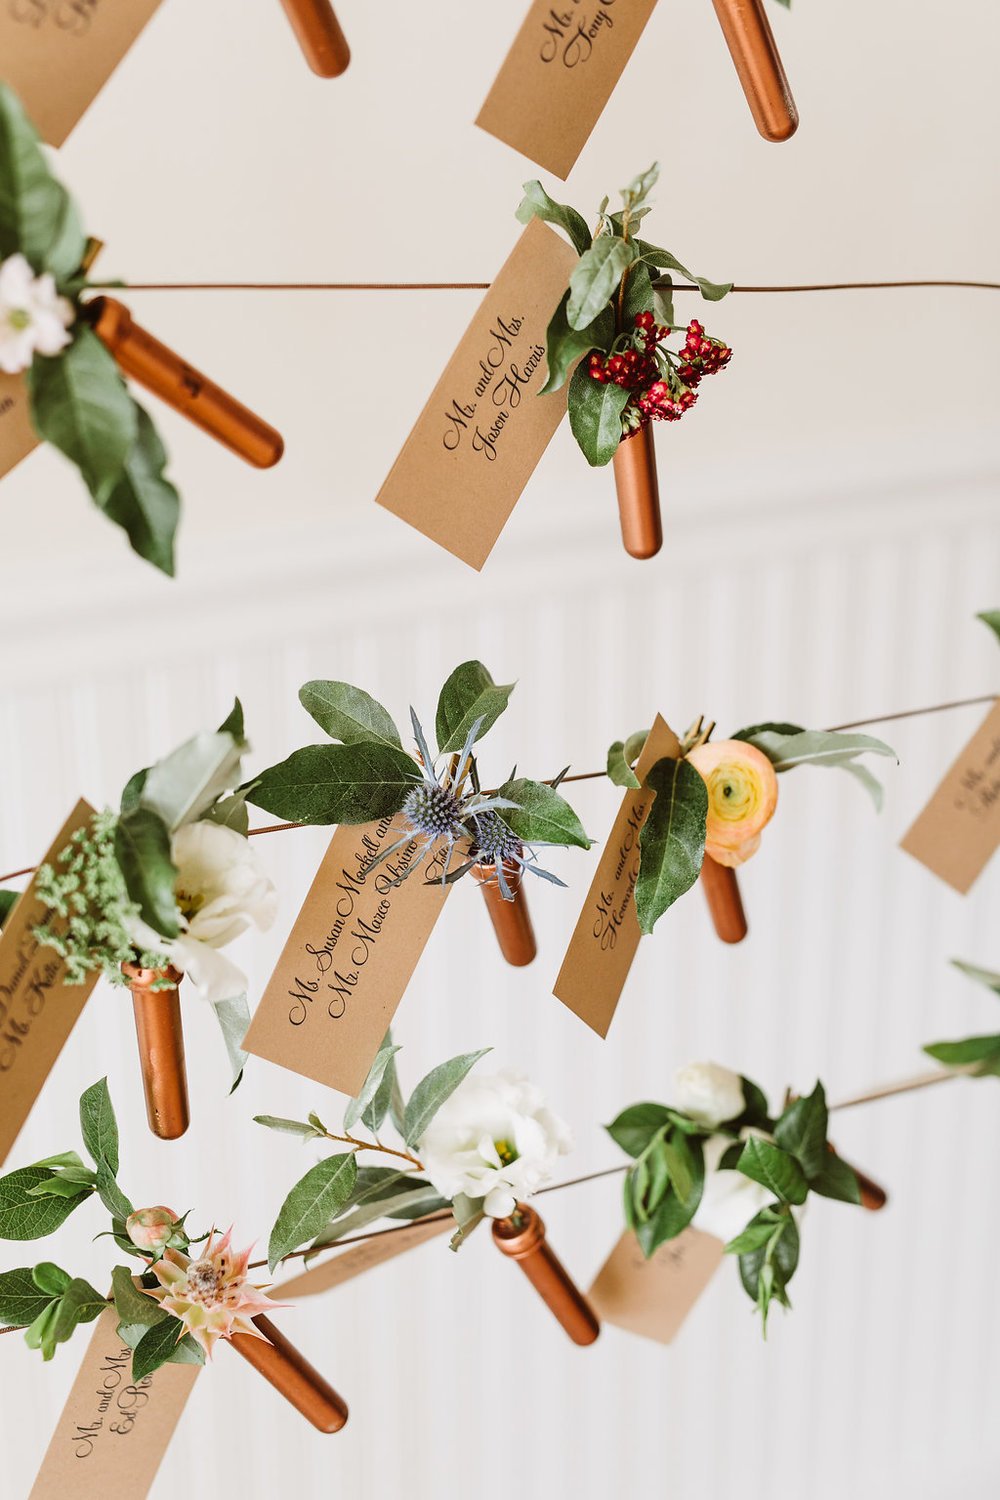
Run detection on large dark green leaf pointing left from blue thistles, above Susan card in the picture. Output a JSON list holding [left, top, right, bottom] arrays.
[[247, 741, 420, 824]]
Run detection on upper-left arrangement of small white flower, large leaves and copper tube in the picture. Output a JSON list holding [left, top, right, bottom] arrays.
[[0, 84, 283, 575]]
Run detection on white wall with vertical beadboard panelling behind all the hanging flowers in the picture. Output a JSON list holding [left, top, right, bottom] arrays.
[[0, 0, 1000, 1500]]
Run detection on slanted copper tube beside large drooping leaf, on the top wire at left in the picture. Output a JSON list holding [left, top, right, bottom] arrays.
[[87, 297, 285, 468]]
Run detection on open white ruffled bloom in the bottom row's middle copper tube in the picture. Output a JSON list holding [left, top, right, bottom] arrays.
[[417, 1071, 573, 1218]]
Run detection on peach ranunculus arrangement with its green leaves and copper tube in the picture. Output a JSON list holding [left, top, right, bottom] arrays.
[[607, 717, 895, 944]]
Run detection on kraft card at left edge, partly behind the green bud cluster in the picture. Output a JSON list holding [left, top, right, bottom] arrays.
[[0, 801, 97, 1164]]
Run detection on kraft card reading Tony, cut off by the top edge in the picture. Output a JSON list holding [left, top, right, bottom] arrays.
[[475, 0, 657, 177]]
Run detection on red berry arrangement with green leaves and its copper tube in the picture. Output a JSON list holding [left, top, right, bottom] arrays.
[[517, 162, 732, 558]]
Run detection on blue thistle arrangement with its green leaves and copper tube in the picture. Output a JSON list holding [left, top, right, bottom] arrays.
[[246, 662, 591, 966]]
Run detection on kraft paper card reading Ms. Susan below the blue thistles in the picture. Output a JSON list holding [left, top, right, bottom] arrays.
[[243, 818, 453, 1095]]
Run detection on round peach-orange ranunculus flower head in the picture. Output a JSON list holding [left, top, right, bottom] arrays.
[[687, 740, 778, 866]]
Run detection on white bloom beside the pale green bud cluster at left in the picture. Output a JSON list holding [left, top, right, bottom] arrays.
[[130, 822, 277, 1005]]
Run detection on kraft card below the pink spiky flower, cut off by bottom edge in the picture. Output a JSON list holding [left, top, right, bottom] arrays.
[[30, 1308, 201, 1500]]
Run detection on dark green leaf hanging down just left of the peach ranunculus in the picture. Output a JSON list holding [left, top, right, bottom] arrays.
[[636, 759, 708, 933]]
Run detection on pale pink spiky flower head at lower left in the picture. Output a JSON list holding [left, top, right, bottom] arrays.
[[150, 1229, 279, 1358]]
